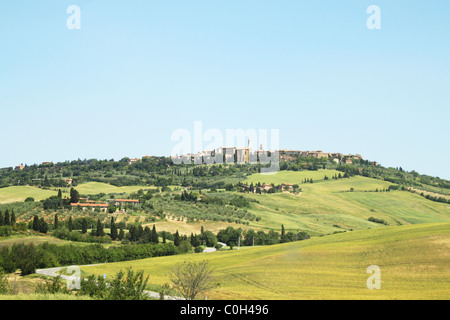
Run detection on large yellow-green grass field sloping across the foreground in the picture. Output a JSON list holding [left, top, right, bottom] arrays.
[[83, 223, 450, 300]]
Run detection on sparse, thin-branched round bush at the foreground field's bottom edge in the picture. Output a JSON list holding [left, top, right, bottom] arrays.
[[169, 261, 218, 300]]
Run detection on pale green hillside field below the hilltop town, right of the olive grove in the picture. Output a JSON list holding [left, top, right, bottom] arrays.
[[244, 172, 450, 235]]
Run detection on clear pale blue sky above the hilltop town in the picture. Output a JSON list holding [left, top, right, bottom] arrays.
[[0, 0, 450, 179]]
